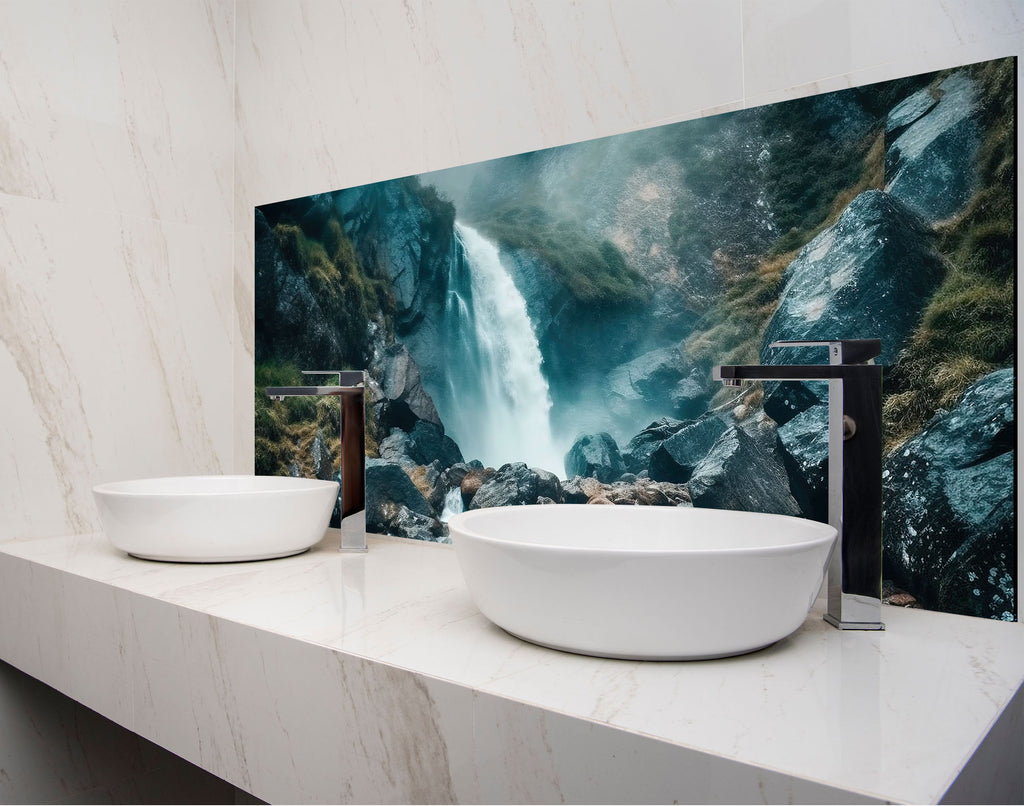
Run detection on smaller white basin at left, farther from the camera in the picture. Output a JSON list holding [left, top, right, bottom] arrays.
[[92, 476, 338, 562]]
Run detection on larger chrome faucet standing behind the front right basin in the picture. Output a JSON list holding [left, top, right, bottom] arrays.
[[712, 339, 885, 630]]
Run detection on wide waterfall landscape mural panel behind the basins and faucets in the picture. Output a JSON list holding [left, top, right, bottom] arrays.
[[255, 58, 1018, 620]]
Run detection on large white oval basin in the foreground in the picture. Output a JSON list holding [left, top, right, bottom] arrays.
[[449, 504, 836, 661]]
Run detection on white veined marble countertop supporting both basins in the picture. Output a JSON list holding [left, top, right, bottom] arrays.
[[0, 535, 1024, 803]]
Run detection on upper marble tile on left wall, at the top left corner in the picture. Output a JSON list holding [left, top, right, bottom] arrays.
[[0, 0, 233, 230]]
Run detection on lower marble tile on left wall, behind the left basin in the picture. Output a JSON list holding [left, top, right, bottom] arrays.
[[0, 196, 233, 539]]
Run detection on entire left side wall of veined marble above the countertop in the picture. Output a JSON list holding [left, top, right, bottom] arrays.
[[0, 0, 234, 540]]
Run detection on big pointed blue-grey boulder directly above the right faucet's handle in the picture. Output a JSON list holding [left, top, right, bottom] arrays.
[[761, 190, 945, 365]]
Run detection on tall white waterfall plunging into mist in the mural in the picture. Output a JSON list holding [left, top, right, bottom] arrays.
[[441, 223, 563, 475]]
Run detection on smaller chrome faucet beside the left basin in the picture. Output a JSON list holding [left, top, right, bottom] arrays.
[[264, 370, 367, 551]]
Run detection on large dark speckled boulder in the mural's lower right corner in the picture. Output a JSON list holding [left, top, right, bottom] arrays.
[[882, 369, 1017, 621]]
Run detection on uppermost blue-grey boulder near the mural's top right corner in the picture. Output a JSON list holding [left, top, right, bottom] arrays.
[[885, 72, 981, 223]]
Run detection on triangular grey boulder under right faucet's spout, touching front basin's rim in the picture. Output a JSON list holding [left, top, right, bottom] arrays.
[[688, 425, 801, 515]]
